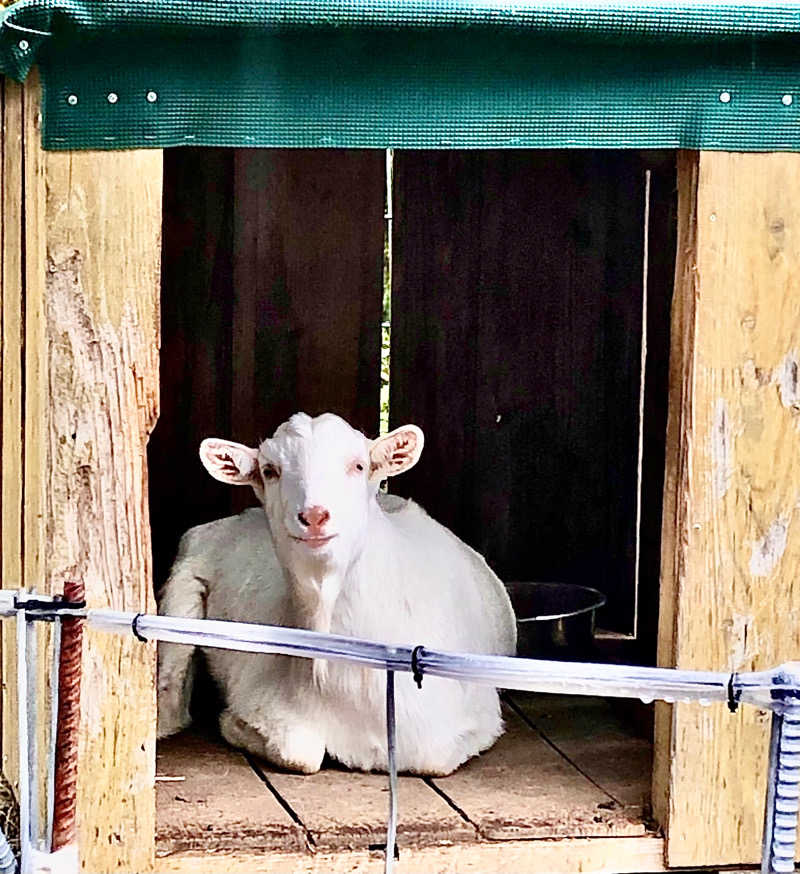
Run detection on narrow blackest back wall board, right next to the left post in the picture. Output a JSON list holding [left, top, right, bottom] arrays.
[[148, 148, 238, 584]]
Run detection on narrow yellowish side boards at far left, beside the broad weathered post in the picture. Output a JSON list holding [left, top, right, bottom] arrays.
[[2, 72, 57, 813]]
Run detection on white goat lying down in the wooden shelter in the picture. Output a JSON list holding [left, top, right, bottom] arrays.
[[158, 413, 516, 775]]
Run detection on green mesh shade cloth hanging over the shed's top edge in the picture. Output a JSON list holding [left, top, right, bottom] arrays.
[[0, 0, 800, 151]]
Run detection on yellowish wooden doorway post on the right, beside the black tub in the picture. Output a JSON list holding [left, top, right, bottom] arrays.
[[653, 152, 800, 866]]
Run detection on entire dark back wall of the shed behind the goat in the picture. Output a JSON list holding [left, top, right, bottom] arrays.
[[149, 149, 675, 662]]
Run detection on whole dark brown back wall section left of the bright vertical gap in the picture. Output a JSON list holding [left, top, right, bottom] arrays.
[[150, 149, 385, 582]]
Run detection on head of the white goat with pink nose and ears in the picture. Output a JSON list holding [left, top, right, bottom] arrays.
[[200, 413, 424, 577]]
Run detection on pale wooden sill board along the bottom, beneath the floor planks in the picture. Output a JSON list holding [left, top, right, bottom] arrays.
[[159, 836, 667, 874]]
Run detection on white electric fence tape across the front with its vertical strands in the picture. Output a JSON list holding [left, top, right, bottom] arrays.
[[0, 590, 800, 874]]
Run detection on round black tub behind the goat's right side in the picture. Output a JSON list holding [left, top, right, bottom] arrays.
[[506, 582, 606, 661]]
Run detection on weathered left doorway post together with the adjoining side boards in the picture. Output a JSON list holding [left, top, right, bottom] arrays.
[[2, 75, 162, 872]]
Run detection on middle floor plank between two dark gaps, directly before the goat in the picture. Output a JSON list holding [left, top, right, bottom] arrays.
[[253, 764, 476, 851]]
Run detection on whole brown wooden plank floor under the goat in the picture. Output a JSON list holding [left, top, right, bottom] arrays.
[[156, 693, 651, 858]]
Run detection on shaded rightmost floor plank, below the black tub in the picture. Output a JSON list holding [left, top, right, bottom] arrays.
[[509, 692, 653, 821]]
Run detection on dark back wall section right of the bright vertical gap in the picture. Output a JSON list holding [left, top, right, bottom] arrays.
[[390, 151, 668, 631]]
